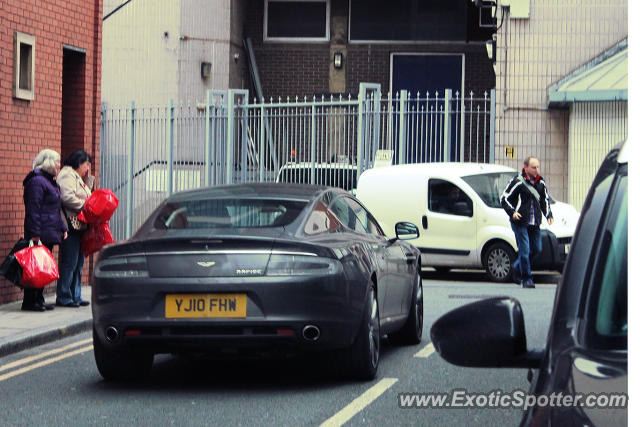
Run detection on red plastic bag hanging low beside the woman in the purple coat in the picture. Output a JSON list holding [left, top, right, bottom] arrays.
[[14, 245, 60, 289]]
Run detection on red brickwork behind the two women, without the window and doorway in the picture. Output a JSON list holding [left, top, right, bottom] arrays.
[[0, 0, 102, 303]]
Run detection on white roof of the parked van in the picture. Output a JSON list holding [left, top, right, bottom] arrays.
[[363, 162, 517, 176]]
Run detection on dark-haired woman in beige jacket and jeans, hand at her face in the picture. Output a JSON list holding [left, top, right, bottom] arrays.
[[56, 150, 95, 307]]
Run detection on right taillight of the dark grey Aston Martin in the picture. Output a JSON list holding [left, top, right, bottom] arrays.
[[267, 255, 342, 276]]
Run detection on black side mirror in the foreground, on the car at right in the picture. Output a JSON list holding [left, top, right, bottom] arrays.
[[431, 297, 543, 368]]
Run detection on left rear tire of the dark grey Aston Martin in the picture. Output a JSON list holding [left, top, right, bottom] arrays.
[[93, 329, 153, 381]]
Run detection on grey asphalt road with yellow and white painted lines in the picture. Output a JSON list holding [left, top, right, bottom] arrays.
[[0, 272, 558, 426]]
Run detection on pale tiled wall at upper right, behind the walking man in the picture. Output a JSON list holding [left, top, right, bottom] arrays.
[[495, 0, 627, 201]]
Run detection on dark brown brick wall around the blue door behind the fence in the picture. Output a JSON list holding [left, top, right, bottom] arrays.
[[245, 0, 495, 99]]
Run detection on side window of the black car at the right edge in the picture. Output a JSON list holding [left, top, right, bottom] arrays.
[[589, 172, 628, 348]]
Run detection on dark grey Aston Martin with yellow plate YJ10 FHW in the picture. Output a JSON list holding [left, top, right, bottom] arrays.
[[92, 184, 422, 379]]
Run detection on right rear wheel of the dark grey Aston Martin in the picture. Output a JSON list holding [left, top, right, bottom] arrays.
[[347, 287, 380, 381]]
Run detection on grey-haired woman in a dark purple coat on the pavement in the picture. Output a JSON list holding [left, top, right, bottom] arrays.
[[22, 149, 67, 311]]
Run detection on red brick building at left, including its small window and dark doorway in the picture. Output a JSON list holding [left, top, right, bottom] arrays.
[[0, 0, 102, 303]]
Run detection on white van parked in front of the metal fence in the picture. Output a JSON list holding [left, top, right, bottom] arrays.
[[356, 163, 579, 282]]
